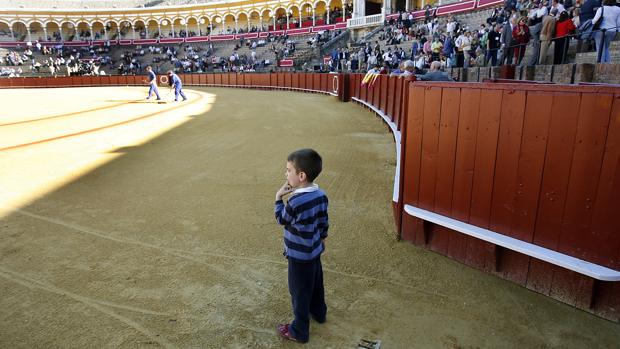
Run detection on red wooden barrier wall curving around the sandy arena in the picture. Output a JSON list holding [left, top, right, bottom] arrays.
[[0, 73, 620, 321]]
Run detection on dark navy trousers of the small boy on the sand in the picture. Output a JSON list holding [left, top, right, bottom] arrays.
[[288, 256, 327, 342]]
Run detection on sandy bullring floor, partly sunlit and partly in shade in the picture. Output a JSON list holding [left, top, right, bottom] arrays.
[[0, 87, 620, 349]]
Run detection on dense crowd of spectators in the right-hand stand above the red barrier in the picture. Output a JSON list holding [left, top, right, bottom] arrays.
[[320, 0, 620, 76]]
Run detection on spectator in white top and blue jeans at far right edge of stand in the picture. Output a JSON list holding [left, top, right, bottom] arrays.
[[592, 0, 620, 63]]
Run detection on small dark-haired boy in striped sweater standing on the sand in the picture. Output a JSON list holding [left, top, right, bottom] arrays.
[[275, 149, 329, 343]]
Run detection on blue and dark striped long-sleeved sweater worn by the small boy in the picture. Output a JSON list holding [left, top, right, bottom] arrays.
[[275, 186, 329, 262]]
